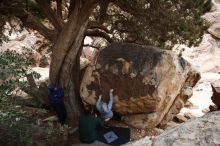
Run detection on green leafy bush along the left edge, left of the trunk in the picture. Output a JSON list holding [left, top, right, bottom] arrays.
[[0, 50, 67, 146]]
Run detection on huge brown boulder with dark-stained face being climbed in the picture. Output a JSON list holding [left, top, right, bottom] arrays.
[[80, 44, 200, 129]]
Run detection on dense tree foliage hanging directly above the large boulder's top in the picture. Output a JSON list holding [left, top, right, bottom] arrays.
[[108, 0, 212, 49]]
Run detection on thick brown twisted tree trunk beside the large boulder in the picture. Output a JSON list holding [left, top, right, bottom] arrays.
[[50, 0, 96, 126]]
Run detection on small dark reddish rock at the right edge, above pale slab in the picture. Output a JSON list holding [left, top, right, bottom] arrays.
[[211, 80, 220, 109]]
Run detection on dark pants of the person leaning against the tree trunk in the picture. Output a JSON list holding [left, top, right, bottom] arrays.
[[53, 102, 67, 125]]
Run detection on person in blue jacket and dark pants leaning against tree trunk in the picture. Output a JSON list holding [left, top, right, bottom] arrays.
[[48, 83, 67, 125]]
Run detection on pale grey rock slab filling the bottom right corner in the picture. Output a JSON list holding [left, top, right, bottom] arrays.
[[152, 111, 220, 146]]
